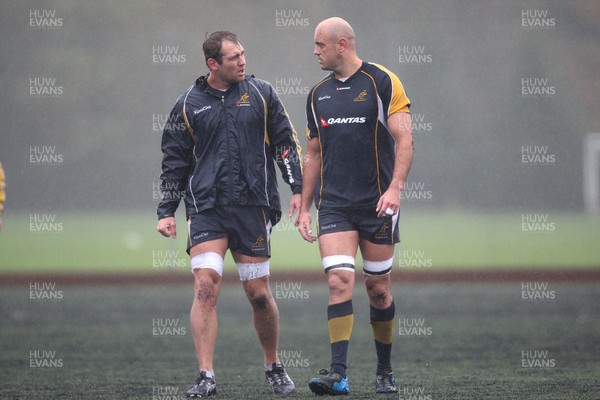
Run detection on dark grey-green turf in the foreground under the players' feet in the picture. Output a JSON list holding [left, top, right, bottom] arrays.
[[0, 282, 600, 400]]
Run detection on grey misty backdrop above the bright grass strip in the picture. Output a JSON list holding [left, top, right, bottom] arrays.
[[0, 0, 600, 218]]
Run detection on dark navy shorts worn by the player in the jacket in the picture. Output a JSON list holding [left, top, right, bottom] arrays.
[[187, 206, 271, 257]]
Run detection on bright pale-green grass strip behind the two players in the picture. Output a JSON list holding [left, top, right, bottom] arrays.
[[0, 210, 600, 273]]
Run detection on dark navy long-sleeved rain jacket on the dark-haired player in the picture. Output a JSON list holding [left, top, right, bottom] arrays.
[[157, 76, 302, 225]]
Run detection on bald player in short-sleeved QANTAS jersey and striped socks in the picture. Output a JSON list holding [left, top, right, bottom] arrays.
[[297, 18, 413, 395]]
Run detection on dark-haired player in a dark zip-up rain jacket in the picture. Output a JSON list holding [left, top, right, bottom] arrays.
[[157, 31, 302, 397]]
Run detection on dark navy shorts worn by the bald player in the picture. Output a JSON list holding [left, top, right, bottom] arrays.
[[318, 207, 400, 244]]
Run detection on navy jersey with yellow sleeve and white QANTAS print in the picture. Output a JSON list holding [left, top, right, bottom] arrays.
[[306, 62, 410, 209]]
